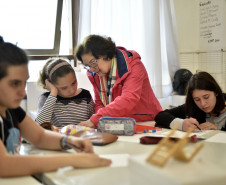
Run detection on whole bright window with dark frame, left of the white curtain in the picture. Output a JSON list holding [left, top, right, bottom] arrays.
[[0, 0, 79, 81]]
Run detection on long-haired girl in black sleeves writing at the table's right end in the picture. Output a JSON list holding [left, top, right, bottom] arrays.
[[155, 72, 226, 131]]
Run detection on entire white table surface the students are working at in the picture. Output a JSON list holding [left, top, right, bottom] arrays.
[[19, 126, 226, 185]]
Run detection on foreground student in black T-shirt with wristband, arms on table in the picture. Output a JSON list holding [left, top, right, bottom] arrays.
[[0, 37, 111, 177]]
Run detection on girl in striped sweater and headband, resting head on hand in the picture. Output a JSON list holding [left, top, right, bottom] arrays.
[[35, 58, 94, 127]]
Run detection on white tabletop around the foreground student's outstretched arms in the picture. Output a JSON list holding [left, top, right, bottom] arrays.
[[20, 136, 154, 185]]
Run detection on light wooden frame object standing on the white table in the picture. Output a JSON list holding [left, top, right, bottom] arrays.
[[147, 126, 203, 166]]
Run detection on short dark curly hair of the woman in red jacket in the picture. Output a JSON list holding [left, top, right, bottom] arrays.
[[75, 35, 116, 63]]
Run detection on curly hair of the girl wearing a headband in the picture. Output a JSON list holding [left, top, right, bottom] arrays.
[[38, 57, 75, 89]]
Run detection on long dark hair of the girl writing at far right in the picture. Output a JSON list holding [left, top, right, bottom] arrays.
[[185, 72, 225, 118]]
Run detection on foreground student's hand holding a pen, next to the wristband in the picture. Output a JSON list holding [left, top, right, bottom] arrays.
[[67, 136, 94, 153]]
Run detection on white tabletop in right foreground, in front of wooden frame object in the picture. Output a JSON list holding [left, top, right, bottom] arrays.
[[129, 142, 226, 185]]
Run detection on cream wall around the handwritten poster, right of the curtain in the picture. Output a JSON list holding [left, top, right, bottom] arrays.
[[174, 0, 226, 92]]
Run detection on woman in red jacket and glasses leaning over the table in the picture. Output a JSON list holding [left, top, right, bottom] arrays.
[[76, 35, 162, 128]]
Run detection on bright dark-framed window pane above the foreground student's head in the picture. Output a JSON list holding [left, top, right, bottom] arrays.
[[0, 0, 63, 55]]
